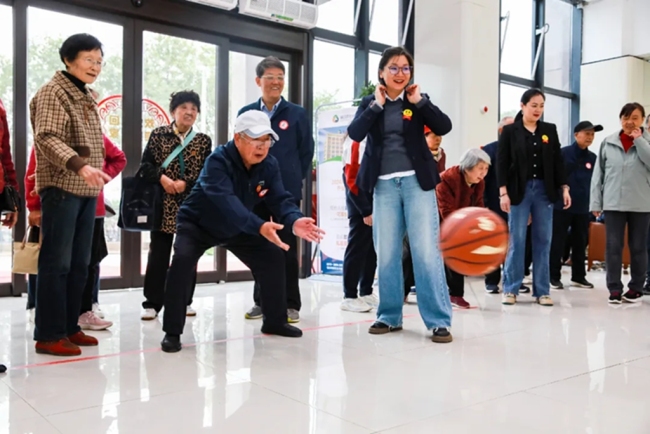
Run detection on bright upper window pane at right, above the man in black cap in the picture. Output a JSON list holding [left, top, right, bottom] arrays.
[[544, 0, 574, 91]]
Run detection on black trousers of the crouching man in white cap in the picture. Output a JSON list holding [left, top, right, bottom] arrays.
[[163, 222, 287, 335]]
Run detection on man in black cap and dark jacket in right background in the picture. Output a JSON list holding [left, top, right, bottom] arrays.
[[549, 121, 603, 289]]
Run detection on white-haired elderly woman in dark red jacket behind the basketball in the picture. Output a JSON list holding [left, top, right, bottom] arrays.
[[436, 148, 491, 309]]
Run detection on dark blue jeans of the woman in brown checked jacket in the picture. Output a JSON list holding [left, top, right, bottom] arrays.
[[34, 187, 97, 341]]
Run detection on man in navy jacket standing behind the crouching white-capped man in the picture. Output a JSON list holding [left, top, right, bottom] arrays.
[[239, 57, 314, 322]]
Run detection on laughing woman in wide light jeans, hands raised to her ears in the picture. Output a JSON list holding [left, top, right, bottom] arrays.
[[348, 47, 452, 343]]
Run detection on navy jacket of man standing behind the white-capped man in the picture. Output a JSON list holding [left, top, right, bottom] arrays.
[[237, 98, 314, 202]]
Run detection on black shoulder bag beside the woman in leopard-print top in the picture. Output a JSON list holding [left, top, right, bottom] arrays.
[[117, 168, 163, 232]]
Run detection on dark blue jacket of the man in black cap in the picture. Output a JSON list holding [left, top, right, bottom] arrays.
[[555, 142, 596, 214]]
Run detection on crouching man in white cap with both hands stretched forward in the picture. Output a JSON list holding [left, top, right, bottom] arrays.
[[161, 111, 322, 352]]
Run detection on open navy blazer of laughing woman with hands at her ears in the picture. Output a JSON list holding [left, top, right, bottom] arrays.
[[348, 94, 451, 191]]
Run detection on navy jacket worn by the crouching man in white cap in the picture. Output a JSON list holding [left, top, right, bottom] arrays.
[[178, 141, 303, 244]]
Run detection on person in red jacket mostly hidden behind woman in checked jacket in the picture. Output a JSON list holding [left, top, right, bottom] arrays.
[[25, 136, 126, 330]]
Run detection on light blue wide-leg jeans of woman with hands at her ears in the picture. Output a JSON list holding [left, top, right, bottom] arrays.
[[372, 175, 451, 329]]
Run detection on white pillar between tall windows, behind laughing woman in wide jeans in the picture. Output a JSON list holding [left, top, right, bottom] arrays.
[[413, 0, 499, 167]]
